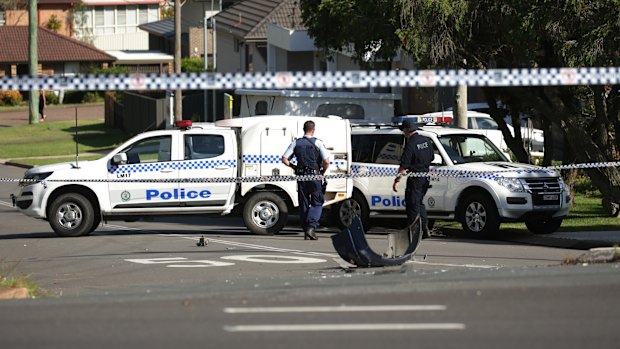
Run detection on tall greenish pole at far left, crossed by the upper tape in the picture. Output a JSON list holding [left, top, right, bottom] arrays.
[[28, 0, 39, 124]]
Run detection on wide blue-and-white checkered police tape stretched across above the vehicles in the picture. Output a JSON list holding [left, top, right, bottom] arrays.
[[0, 67, 620, 91]]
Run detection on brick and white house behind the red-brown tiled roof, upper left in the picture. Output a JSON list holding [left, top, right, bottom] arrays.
[[0, 0, 174, 73]]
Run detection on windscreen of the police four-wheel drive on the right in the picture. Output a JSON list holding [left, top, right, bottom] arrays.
[[439, 135, 508, 164]]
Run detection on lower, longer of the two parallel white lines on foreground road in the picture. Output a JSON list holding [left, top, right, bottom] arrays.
[[224, 323, 465, 332]]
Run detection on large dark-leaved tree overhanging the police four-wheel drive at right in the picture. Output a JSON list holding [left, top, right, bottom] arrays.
[[301, 0, 620, 216]]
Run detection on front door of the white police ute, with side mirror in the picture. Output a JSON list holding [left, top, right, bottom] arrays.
[[108, 134, 179, 212]]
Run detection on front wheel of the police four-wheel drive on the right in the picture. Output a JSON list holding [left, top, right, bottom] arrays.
[[459, 193, 500, 237]]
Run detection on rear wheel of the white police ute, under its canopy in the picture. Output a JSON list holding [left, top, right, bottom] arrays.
[[243, 192, 288, 235]]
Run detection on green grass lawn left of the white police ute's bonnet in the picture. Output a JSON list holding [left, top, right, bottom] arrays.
[[0, 120, 128, 158]]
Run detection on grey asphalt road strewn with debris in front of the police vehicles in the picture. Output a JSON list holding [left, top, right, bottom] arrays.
[[0, 166, 620, 349]]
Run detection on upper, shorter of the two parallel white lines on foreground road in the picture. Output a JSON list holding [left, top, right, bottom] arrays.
[[224, 305, 446, 314]]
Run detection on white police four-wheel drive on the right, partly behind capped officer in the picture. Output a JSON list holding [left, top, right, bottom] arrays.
[[333, 121, 571, 235]]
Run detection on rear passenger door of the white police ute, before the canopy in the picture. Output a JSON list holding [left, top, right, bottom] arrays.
[[179, 130, 237, 207]]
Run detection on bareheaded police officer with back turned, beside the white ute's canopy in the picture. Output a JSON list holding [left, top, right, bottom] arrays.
[[282, 120, 329, 240]]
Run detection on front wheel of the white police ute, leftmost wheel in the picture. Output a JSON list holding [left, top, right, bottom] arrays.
[[47, 193, 96, 237]]
